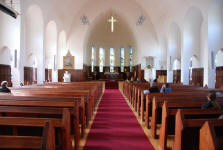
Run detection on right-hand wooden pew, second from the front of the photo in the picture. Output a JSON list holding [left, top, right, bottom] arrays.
[[172, 110, 223, 150]]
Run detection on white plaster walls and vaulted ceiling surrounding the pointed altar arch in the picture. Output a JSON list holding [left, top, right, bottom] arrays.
[[0, 0, 223, 87]]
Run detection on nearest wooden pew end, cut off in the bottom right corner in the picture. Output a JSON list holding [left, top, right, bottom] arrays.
[[199, 119, 223, 150]]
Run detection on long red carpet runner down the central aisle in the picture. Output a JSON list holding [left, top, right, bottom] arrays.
[[84, 90, 154, 150]]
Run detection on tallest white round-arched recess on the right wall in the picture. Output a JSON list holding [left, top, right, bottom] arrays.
[[181, 7, 203, 84]]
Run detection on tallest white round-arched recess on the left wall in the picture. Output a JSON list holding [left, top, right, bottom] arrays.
[[23, 5, 45, 83]]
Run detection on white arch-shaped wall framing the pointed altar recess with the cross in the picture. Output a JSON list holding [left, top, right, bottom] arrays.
[[68, 0, 160, 69]]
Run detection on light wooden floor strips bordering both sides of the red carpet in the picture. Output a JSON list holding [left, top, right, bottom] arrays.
[[80, 82, 174, 150]]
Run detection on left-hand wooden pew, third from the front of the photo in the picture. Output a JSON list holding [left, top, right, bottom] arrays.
[[0, 97, 80, 150]]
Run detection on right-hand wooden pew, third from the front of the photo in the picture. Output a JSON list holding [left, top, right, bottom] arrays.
[[159, 100, 223, 150]]
